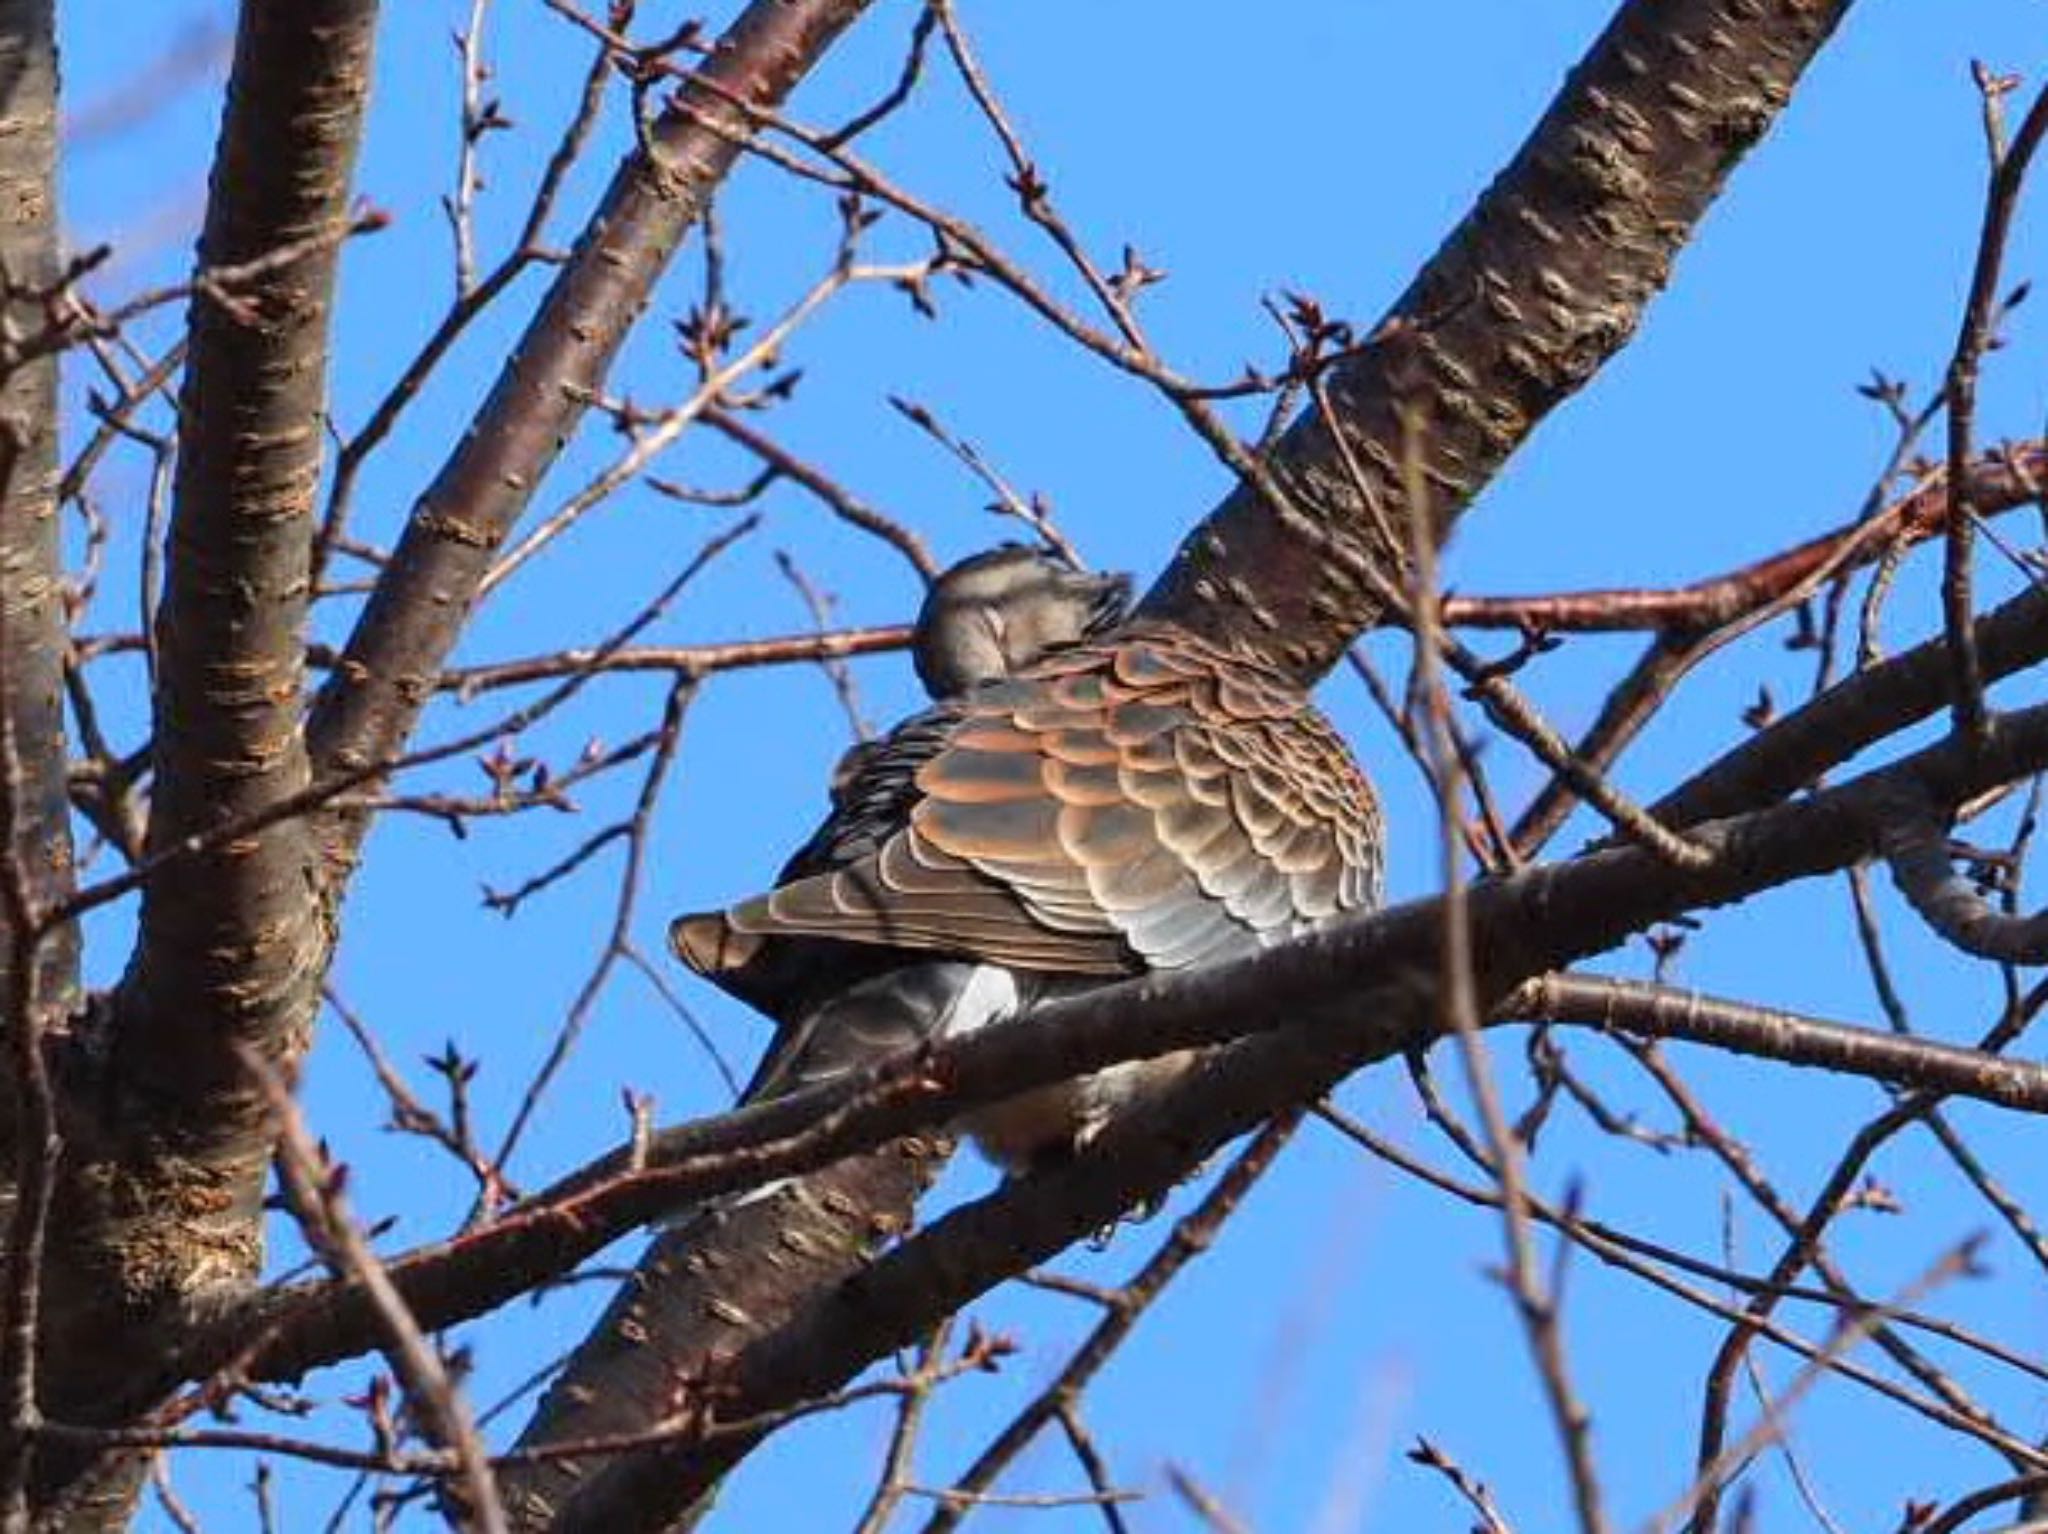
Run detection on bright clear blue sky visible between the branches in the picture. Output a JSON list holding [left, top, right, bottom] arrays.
[[63, 0, 2048, 1534]]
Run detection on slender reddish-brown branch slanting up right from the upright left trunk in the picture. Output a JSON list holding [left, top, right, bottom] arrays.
[[311, 0, 868, 860]]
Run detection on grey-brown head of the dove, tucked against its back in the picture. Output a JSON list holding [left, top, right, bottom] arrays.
[[911, 543, 1130, 698]]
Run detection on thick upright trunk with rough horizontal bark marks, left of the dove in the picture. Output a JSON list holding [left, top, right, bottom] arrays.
[[45, 0, 377, 1507]]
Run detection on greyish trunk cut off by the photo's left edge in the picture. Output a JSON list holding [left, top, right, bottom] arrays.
[[0, 0, 78, 1071]]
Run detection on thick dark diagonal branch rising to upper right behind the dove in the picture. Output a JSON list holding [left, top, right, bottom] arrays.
[[1143, 0, 1849, 682]]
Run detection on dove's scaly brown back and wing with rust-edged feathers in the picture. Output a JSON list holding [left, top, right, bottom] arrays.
[[678, 627, 1380, 975]]
